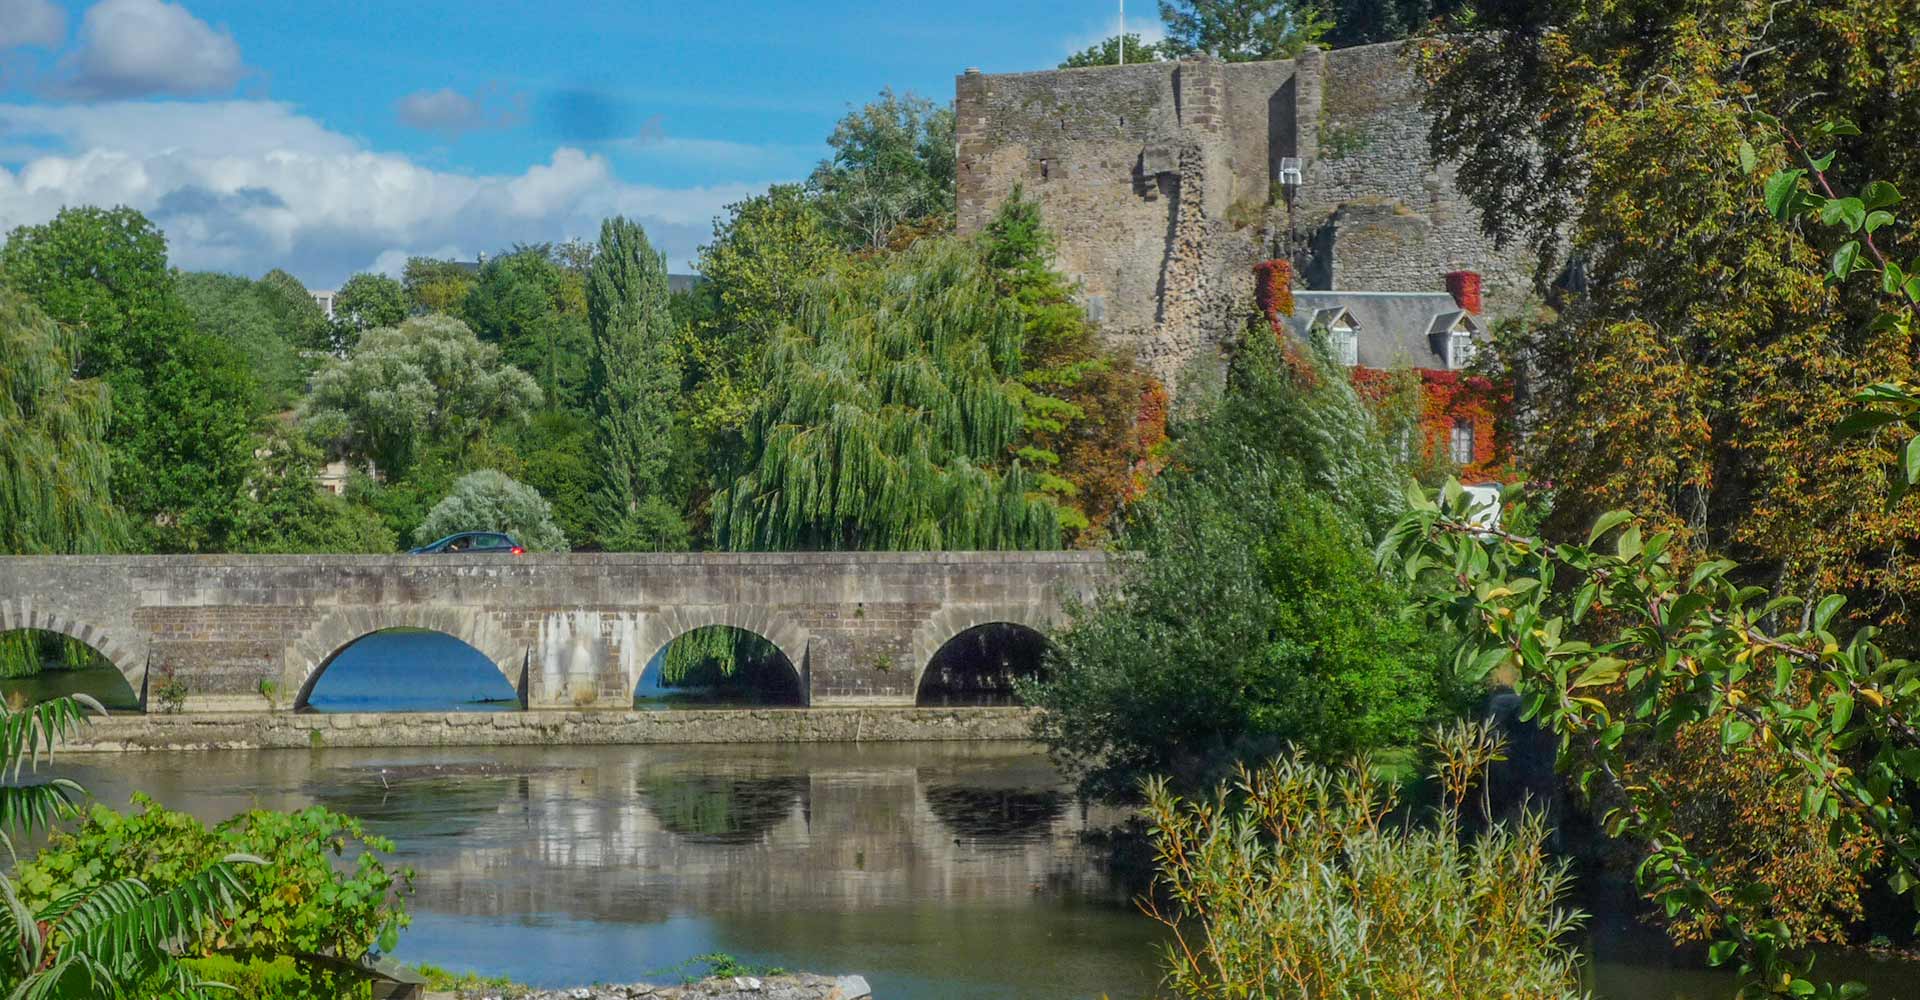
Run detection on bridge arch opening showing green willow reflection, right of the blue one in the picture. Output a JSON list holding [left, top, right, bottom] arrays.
[[634, 626, 806, 708]]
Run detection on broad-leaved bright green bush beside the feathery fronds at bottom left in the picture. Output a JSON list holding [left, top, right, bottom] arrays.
[[15, 795, 413, 975]]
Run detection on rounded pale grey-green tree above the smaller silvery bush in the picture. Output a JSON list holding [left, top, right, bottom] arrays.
[[300, 317, 541, 478]]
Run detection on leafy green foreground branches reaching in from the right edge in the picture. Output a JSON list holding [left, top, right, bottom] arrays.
[[1380, 128, 1920, 996]]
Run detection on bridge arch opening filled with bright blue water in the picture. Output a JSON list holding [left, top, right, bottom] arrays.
[[294, 628, 520, 712]]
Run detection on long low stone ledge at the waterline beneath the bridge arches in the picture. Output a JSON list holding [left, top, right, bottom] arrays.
[[61, 706, 1033, 752]]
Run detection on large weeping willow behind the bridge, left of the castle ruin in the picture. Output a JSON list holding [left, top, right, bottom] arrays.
[[712, 240, 1060, 551]]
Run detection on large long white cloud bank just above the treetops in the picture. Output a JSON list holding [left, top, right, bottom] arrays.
[[0, 102, 766, 288]]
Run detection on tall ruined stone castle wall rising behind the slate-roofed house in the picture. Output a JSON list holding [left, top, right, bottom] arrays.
[[954, 42, 1530, 388]]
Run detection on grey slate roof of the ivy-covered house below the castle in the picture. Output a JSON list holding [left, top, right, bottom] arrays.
[[1283, 290, 1486, 369]]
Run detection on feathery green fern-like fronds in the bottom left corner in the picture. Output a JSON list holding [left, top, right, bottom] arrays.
[[0, 697, 263, 1000]]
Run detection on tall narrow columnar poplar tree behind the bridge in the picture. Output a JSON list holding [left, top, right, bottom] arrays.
[[588, 217, 687, 549]]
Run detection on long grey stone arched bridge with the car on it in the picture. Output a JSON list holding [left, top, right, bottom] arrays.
[[0, 553, 1110, 710]]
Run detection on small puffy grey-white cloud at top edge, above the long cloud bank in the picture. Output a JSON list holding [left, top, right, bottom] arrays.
[[54, 0, 246, 100]]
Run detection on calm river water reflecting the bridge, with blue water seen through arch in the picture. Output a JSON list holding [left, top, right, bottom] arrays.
[[0, 637, 1920, 1000]]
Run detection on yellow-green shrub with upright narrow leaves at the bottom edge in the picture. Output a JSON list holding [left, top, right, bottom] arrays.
[[1142, 724, 1584, 1000]]
